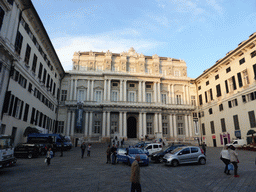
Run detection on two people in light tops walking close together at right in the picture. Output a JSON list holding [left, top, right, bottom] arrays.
[[220, 145, 239, 177]]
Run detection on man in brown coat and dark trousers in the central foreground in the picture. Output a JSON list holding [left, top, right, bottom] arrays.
[[131, 155, 141, 192]]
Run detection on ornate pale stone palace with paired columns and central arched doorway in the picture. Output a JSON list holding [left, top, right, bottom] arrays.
[[58, 48, 200, 141]]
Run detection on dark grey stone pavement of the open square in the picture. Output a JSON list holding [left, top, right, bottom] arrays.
[[0, 143, 256, 192]]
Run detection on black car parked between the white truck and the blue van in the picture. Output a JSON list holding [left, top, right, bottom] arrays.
[[14, 143, 40, 159]]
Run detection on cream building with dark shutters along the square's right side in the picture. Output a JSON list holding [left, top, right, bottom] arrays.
[[195, 33, 256, 146]]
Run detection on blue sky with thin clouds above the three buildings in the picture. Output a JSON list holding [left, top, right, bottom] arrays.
[[32, 0, 256, 78]]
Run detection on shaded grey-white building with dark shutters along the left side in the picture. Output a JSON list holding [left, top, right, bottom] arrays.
[[0, 0, 65, 144]]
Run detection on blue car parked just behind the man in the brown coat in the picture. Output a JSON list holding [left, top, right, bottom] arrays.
[[116, 148, 149, 165]]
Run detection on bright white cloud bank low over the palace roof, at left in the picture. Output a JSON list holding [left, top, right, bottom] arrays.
[[52, 29, 164, 71]]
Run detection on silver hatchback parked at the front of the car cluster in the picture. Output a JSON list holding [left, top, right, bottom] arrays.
[[163, 146, 206, 167]]
